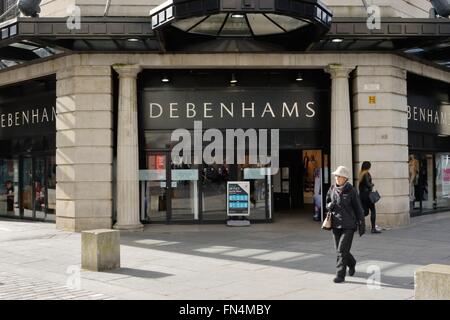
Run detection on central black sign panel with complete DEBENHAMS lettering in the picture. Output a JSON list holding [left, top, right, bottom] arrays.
[[140, 90, 329, 130]]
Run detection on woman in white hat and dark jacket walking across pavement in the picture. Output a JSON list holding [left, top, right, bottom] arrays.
[[326, 166, 365, 283]]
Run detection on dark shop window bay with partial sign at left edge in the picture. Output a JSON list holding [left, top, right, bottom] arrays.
[[0, 77, 56, 221]]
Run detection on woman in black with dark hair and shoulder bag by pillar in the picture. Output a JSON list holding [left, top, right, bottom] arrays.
[[358, 161, 381, 233]]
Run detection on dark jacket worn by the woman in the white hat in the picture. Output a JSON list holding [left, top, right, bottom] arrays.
[[326, 182, 365, 230]]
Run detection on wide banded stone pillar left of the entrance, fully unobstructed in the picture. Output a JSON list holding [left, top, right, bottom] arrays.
[[56, 66, 113, 232]]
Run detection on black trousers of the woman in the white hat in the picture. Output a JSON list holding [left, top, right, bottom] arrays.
[[333, 229, 356, 278]]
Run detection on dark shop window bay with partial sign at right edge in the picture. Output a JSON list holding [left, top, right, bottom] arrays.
[[408, 74, 450, 215]]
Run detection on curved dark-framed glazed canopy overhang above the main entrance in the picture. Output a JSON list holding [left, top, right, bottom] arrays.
[[150, 0, 333, 50]]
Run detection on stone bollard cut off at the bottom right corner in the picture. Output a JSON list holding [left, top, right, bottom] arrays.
[[414, 264, 450, 300]]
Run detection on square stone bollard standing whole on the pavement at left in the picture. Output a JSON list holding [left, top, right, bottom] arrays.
[[81, 229, 120, 271]]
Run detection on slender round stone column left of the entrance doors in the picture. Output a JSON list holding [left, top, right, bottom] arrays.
[[114, 65, 143, 231]]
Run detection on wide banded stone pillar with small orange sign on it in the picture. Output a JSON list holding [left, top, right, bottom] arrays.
[[353, 66, 409, 227]]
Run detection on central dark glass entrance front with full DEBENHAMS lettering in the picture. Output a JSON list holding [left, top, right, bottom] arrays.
[[138, 69, 330, 222]]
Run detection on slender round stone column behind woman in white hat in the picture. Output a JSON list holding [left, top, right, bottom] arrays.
[[325, 65, 353, 181]]
